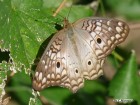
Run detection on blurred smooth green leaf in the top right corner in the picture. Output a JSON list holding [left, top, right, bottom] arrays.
[[105, 0, 140, 20]]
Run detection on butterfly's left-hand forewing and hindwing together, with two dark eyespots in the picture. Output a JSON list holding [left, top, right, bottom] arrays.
[[33, 29, 84, 92]]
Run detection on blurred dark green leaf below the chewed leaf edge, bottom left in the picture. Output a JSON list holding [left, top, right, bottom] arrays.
[[6, 71, 32, 105]]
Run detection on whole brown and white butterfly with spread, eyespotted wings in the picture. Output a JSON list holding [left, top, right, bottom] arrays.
[[33, 17, 129, 93]]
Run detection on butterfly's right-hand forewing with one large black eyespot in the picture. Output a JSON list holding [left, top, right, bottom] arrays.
[[74, 18, 129, 58]]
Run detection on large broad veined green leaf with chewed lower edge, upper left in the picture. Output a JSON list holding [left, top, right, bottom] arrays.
[[0, 0, 58, 70]]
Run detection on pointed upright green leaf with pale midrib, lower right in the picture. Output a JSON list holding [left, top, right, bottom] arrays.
[[109, 51, 140, 101]]
